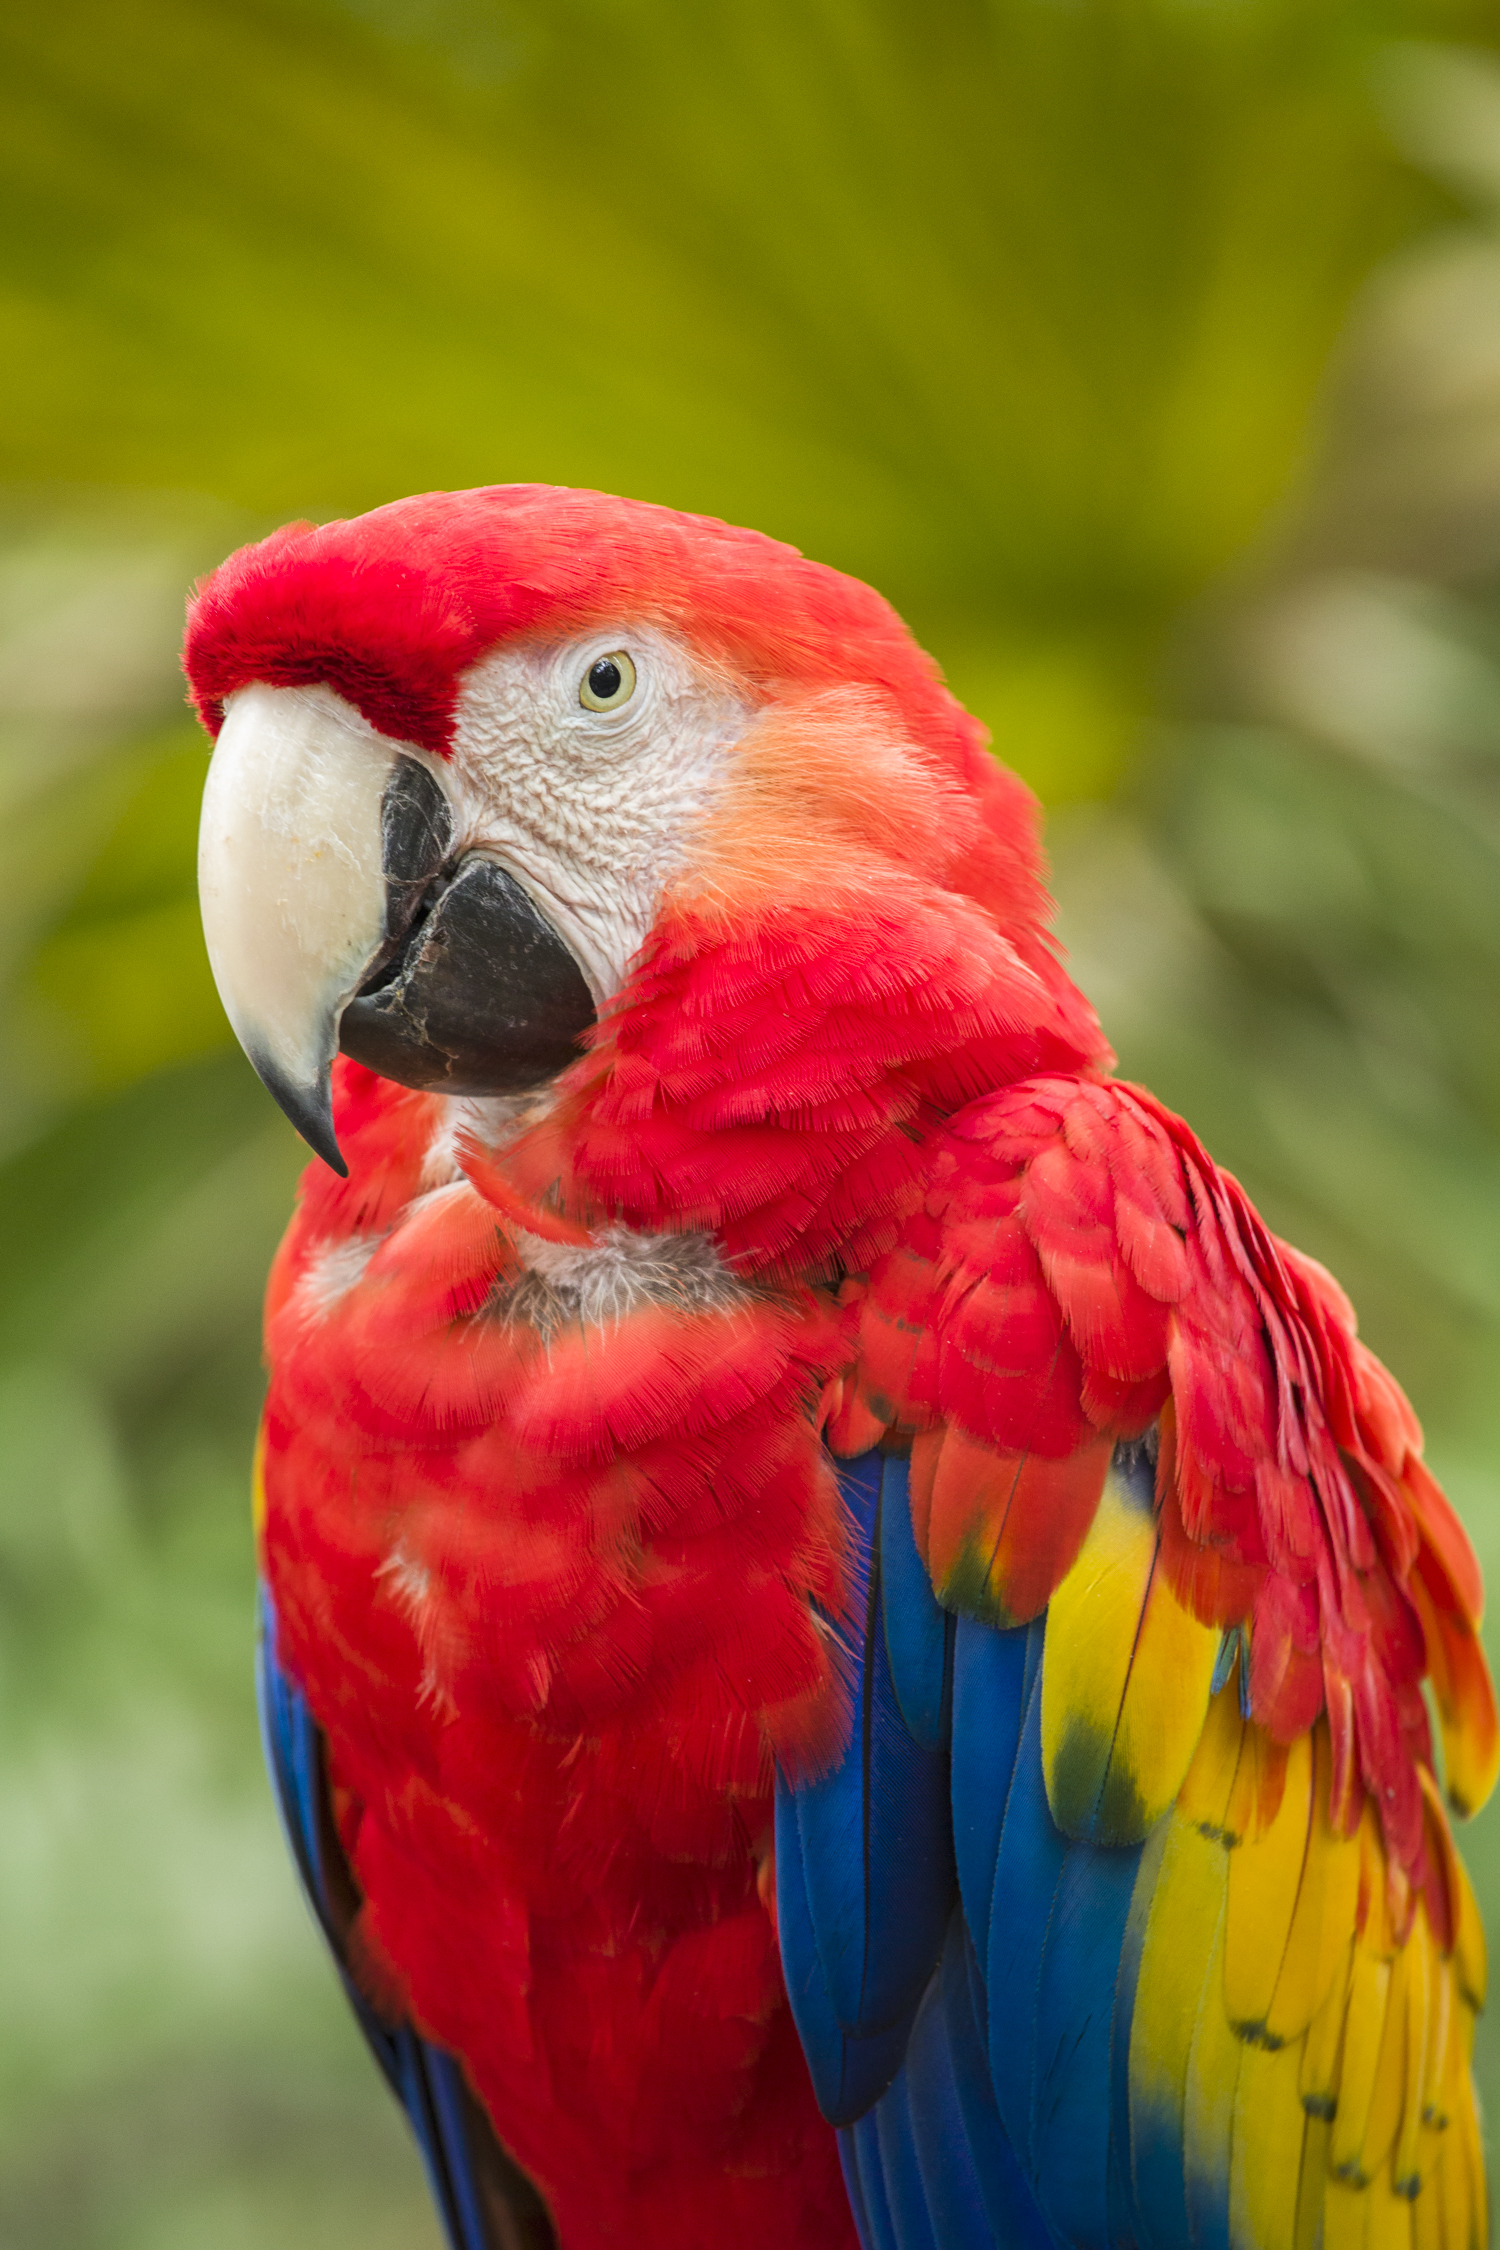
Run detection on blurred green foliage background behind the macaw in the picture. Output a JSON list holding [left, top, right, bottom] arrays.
[[0, 0, 1500, 2250]]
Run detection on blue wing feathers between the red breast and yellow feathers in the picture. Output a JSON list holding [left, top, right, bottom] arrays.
[[778, 1456, 1187, 2250]]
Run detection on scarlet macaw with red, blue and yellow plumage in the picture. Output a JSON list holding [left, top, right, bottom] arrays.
[[187, 486, 1500, 2250]]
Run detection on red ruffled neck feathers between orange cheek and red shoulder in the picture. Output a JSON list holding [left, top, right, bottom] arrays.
[[501, 893, 1111, 1280]]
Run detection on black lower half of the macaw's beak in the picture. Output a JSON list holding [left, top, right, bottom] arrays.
[[340, 853, 596, 1094]]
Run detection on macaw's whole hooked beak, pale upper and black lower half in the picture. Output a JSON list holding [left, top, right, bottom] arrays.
[[198, 686, 594, 1175]]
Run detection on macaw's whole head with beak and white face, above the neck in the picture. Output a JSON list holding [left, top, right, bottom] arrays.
[[184, 486, 1104, 1206]]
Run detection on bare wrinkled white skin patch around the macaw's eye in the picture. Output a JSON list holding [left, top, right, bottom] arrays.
[[448, 626, 753, 1001]]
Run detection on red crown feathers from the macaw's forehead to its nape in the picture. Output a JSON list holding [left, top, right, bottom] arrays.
[[184, 484, 1050, 936]]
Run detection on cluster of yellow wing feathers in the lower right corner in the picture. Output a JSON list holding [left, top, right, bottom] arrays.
[[1129, 1683, 1487, 2250]]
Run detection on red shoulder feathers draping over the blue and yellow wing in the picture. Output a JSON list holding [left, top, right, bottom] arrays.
[[843, 1078, 1500, 1883]]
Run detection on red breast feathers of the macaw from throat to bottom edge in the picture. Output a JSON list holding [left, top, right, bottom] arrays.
[[265, 1067, 852, 2246]]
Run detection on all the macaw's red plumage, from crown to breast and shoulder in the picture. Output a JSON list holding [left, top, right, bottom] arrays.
[[189, 488, 1496, 2250]]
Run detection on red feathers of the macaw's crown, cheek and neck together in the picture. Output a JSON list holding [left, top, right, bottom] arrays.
[[187, 486, 1109, 1262]]
